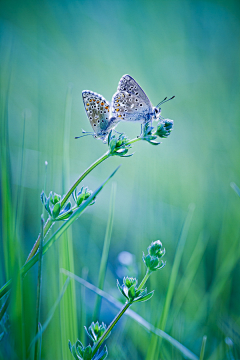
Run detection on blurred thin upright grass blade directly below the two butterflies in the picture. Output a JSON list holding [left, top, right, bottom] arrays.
[[93, 183, 117, 321]]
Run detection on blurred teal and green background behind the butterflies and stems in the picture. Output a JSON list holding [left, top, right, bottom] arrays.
[[0, 0, 240, 360]]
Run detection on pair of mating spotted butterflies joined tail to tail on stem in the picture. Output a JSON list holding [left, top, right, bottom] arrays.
[[76, 75, 174, 142]]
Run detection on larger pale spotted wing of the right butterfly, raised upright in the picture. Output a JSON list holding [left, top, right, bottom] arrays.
[[112, 75, 152, 122]]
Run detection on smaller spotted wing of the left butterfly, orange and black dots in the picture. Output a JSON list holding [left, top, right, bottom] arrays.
[[82, 90, 110, 137]]
